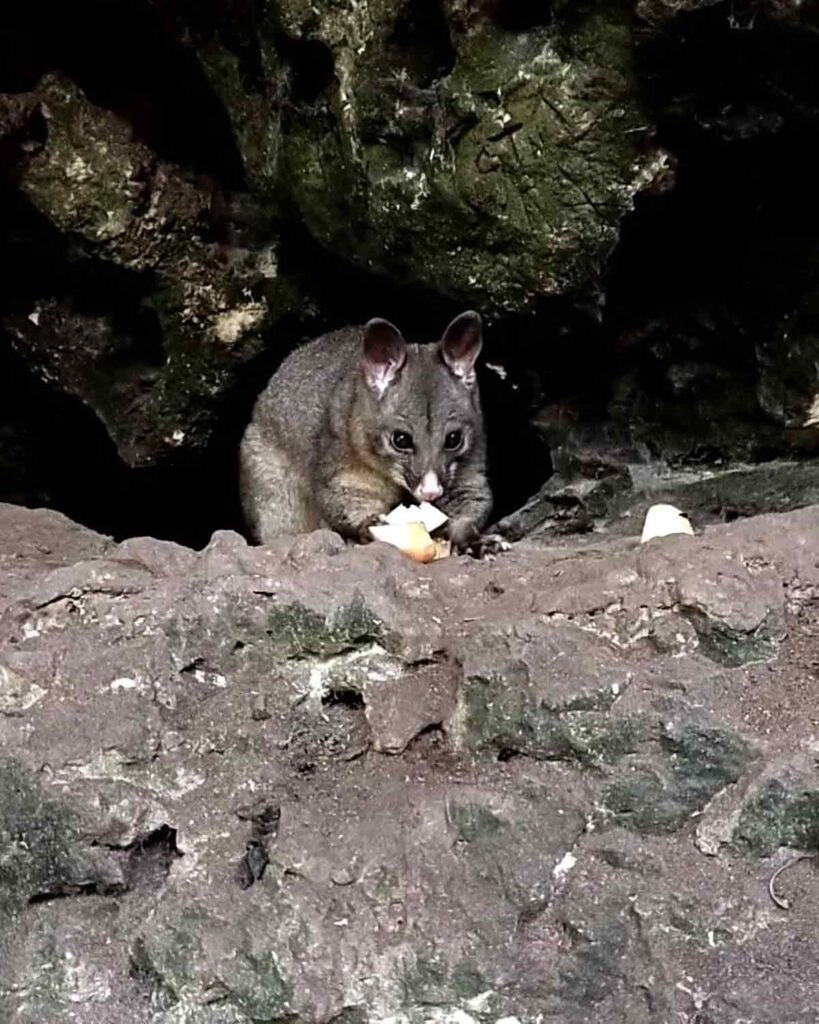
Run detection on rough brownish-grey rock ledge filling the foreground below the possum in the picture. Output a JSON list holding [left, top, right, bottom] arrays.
[[0, 506, 819, 1024]]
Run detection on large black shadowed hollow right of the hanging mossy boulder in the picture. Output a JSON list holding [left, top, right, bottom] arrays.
[[589, 2, 819, 464]]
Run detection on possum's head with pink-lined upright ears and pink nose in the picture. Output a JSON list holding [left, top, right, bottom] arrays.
[[360, 310, 484, 503]]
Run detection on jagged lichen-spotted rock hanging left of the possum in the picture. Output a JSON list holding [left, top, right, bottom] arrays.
[[4, 76, 276, 466]]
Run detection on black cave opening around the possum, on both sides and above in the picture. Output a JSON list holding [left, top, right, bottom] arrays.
[[0, 229, 552, 548]]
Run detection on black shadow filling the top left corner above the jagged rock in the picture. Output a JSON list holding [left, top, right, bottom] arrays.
[[0, 0, 249, 190]]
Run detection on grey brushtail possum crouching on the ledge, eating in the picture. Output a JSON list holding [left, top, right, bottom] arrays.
[[240, 311, 494, 550]]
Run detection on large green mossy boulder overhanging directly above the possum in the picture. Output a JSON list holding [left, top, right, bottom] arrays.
[[274, 3, 659, 308]]
